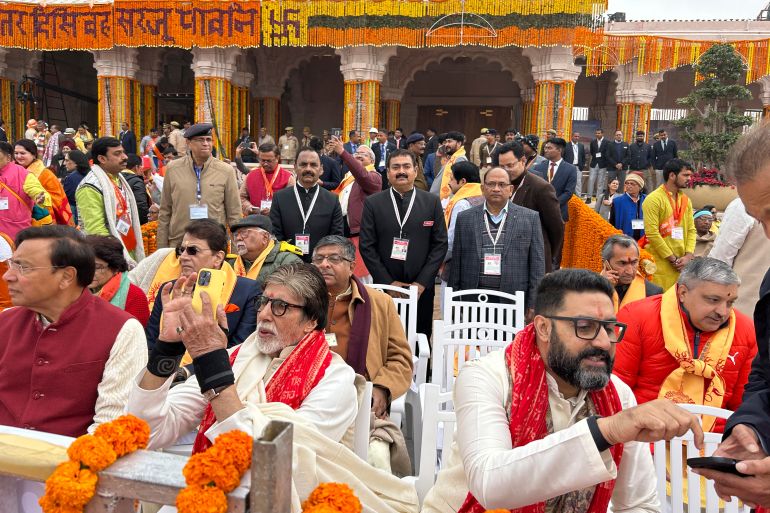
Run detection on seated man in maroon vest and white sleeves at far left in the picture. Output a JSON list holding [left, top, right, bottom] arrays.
[[0, 225, 147, 436]]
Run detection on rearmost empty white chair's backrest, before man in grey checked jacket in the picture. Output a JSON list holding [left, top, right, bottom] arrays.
[[442, 287, 525, 331]]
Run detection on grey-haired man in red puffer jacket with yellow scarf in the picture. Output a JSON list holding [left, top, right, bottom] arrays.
[[615, 257, 757, 431]]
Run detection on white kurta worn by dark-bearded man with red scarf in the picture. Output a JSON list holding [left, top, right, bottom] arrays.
[[422, 351, 660, 513]]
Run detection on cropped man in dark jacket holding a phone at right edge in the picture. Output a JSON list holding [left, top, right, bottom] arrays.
[[696, 125, 770, 509]]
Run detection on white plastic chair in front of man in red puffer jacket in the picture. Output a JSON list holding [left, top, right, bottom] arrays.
[[653, 404, 751, 513]]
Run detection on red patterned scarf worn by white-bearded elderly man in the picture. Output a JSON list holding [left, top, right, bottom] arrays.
[[193, 330, 332, 454]]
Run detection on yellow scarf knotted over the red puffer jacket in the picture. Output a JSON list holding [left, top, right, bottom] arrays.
[[658, 285, 735, 431]]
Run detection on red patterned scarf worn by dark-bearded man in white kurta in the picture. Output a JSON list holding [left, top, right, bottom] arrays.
[[458, 324, 623, 513]]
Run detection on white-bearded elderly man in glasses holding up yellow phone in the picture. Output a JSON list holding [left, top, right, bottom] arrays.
[[127, 263, 416, 513]]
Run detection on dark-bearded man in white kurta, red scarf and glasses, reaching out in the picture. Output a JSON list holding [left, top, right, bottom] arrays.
[[422, 269, 703, 513]]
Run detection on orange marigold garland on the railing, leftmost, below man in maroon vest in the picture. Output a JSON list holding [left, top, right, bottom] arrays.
[[38, 415, 150, 513]]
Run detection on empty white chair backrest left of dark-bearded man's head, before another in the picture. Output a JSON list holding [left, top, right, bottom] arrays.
[[430, 320, 518, 392]]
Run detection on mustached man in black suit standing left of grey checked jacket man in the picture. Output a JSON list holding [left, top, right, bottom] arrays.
[[359, 150, 448, 339]]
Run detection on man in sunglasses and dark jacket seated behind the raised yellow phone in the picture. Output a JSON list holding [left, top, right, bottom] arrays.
[[145, 219, 260, 350]]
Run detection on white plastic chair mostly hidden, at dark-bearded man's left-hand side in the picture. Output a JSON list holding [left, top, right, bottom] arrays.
[[402, 383, 456, 506]]
